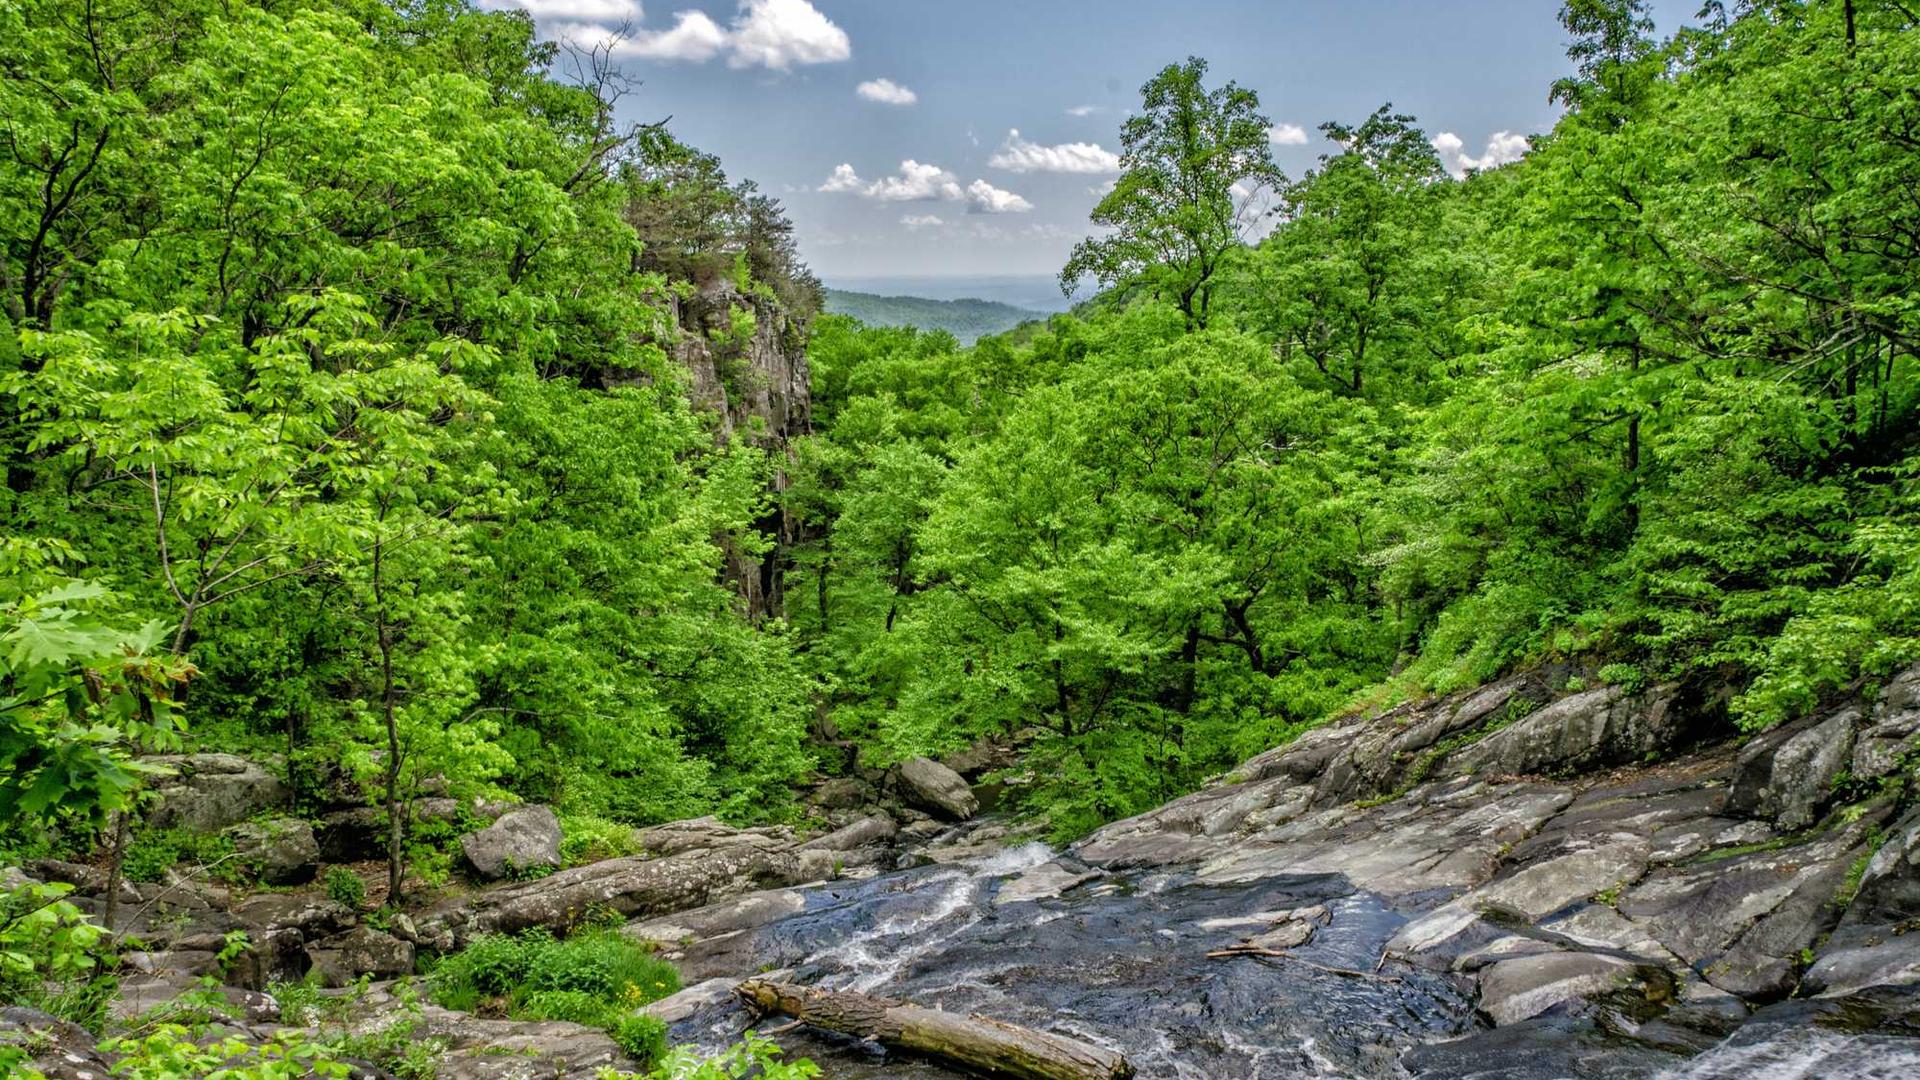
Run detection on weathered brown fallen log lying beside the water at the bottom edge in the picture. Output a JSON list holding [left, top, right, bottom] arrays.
[[733, 978, 1133, 1080]]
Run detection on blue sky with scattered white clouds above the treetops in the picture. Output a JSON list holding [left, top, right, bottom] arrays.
[[482, 0, 1699, 282]]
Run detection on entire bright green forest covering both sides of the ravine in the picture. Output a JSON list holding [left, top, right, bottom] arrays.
[[0, 0, 1920, 1076]]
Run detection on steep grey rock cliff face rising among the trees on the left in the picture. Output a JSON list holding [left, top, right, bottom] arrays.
[[672, 279, 812, 617]]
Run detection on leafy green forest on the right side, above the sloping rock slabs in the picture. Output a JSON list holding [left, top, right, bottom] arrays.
[[789, 2, 1920, 834]]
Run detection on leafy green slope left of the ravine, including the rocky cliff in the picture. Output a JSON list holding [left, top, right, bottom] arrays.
[[0, 2, 818, 884]]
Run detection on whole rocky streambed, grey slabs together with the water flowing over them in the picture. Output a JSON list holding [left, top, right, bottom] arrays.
[[3, 669, 1920, 1080]]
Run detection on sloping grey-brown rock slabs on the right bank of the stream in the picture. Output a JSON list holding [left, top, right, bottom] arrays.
[[1071, 667, 1920, 1042]]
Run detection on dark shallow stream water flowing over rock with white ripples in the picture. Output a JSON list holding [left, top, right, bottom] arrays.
[[674, 826, 1920, 1080]]
